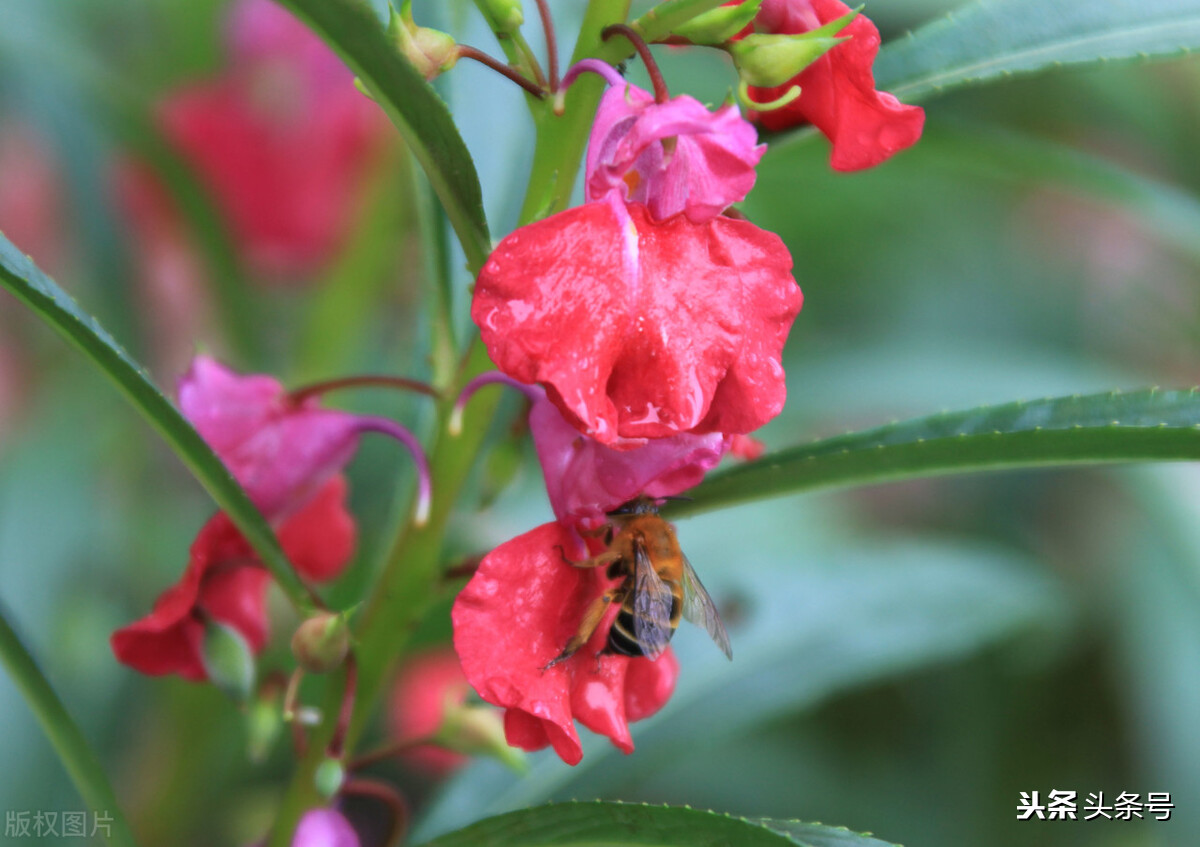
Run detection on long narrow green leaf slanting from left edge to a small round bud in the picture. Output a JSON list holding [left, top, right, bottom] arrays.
[[0, 235, 311, 608]]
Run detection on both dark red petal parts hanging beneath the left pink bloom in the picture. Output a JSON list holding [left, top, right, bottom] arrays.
[[112, 476, 355, 681]]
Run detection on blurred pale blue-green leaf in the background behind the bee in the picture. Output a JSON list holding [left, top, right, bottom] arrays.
[[414, 537, 1067, 839]]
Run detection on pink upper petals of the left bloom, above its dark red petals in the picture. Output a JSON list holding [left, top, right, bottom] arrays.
[[179, 356, 362, 518]]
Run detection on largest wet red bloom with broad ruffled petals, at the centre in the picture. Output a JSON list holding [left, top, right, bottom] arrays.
[[472, 194, 802, 447]]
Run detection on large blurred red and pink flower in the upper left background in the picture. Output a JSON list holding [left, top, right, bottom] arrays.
[[137, 0, 386, 280]]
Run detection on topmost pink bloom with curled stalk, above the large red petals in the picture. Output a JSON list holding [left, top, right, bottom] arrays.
[[563, 60, 767, 223]]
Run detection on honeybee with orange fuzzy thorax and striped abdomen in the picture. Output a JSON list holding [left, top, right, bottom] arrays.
[[546, 497, 733, 667]]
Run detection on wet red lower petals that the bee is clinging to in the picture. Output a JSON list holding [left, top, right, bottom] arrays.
[[451, 523, 679, 764]]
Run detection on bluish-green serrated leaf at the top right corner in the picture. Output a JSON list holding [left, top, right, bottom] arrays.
[[875, 0, 1200, 101]]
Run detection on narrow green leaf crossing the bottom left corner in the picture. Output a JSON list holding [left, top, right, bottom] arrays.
[[0, 609, 137, 847]]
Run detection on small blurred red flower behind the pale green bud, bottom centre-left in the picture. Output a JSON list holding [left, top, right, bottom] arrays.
[[389, 648, 470, 774]]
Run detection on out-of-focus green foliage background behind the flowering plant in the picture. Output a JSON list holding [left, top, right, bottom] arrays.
[[0, 0, 1200, 847]]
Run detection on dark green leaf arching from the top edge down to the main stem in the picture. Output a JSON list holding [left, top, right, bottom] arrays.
[[282, 0, 492, 270]]
